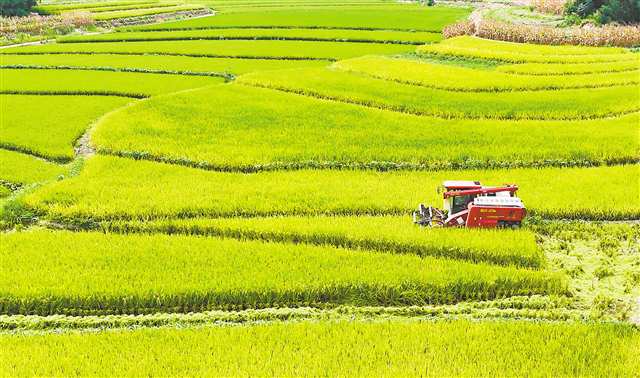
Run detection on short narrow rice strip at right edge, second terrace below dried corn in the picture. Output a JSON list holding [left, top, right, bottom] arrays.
[[496, 61, 640, 75]]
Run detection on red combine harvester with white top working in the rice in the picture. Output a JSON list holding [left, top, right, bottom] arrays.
[[413, 181, 527, 228]]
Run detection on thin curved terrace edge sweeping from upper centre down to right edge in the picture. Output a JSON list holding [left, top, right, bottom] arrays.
[[235, 81, 640, 121]]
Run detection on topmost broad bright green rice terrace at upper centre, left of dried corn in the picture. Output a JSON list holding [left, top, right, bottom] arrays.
[[128, 5, 470, 32]]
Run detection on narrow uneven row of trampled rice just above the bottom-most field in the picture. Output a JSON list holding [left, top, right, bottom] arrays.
[[0, 295, 584, 335]]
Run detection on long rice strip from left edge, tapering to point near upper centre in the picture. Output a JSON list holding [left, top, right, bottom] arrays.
[[2, 54, 329, 75]]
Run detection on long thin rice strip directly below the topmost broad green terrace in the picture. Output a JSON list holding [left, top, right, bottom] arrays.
[[58, 28, 442, 44]]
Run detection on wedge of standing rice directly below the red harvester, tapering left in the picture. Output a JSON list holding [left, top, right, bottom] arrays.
[[106, 216, 545, 268]]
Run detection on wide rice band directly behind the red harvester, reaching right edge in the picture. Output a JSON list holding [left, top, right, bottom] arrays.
[[25, 156, 640, 221]]
